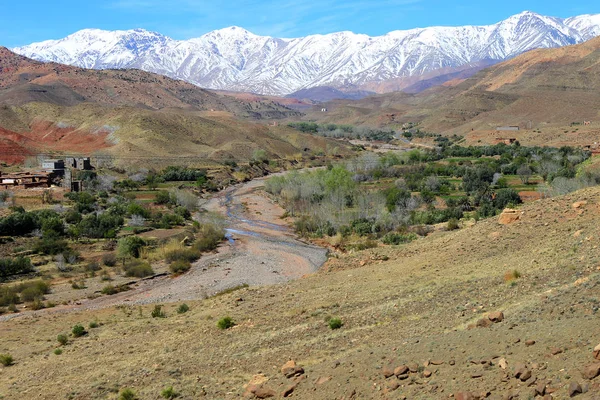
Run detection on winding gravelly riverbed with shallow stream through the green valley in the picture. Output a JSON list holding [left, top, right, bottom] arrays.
[[0, 173, 327, 320]]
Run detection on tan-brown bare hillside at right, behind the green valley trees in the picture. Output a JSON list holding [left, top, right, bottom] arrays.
[[308, 38, 600, 143]]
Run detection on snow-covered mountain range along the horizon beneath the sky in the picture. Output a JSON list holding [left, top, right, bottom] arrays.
[[12, 11, 600, 95]]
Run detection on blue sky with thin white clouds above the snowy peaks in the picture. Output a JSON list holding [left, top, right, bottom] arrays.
[[0, 0, 600, 47]]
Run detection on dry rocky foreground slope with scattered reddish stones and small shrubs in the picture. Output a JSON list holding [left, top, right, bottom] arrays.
[[0, 188, 600, 399]]
